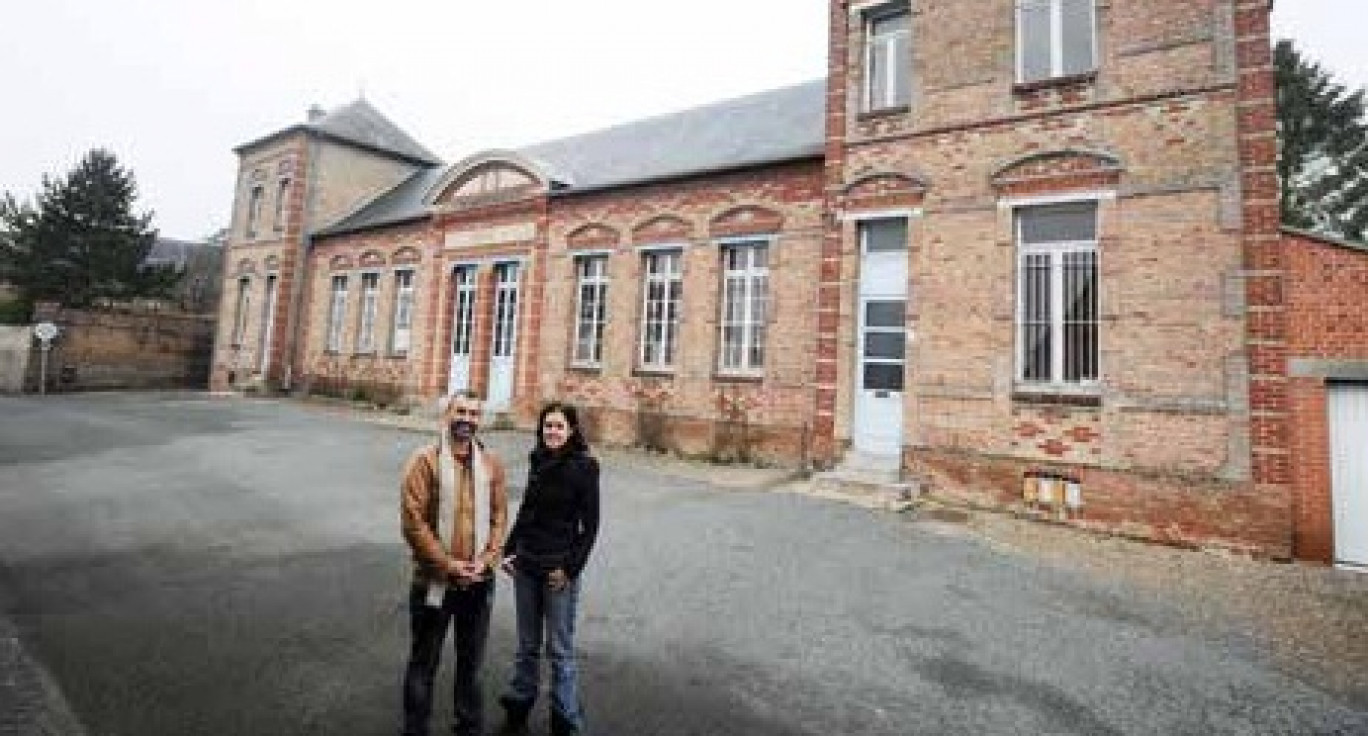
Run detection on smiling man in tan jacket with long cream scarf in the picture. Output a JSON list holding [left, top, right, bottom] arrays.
[[399, 393, 508, 736]]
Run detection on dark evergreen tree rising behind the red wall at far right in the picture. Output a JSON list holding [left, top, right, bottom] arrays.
[[1274, 40, 1368, 241]]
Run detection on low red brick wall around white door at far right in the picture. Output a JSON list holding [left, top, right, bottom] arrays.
[[1283, 234, 1368, 562]]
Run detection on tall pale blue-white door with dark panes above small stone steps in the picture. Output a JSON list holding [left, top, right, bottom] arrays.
[[851, 218, 907, 457]]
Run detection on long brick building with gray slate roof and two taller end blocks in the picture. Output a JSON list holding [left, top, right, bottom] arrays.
[[213, 0, 1368, 562]]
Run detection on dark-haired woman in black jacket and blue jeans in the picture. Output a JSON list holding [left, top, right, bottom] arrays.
[[499, 402, 599, 736]]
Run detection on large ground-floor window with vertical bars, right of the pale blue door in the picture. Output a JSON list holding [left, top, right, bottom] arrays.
[[1016, 202, 1099, 386]]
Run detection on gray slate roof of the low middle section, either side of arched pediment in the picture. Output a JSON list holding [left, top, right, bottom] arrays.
[[317, 79, 826, 235]]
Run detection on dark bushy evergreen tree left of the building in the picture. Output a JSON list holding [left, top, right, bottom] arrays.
[[0, 149, 181, 306]]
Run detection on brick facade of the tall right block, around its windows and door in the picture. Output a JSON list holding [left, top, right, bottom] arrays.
[[817, 0, 1290, 557]]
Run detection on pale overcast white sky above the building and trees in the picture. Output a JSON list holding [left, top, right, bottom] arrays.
[[0, 0, 1368, 239]]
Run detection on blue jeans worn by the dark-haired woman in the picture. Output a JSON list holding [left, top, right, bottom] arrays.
[[505, 570, 584, 729]]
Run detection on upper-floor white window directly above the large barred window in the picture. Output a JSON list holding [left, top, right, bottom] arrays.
[[1016, 0, 1097, 82]]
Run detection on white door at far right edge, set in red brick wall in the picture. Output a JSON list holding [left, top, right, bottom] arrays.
[[1328, 383, 1368, 568]]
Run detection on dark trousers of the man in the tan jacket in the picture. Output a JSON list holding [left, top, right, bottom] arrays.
[[404, 580, 494, 736]]
